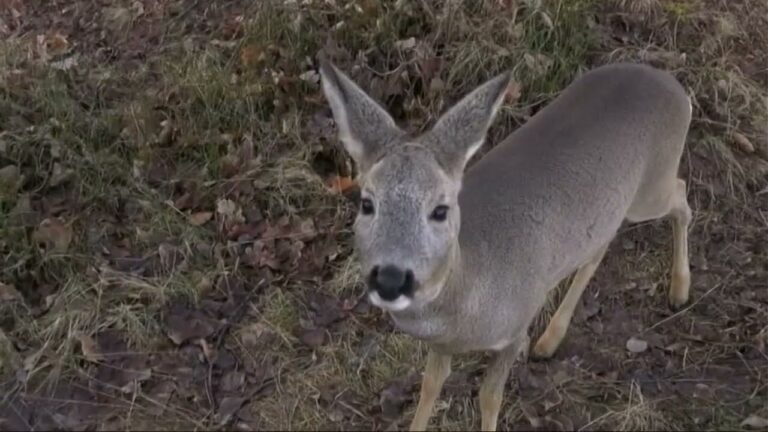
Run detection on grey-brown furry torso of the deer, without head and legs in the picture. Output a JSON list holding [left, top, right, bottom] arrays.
[[390, 65, 690, 353]]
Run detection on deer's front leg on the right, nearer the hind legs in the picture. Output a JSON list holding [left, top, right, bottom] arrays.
[[479, 335, 529, 431]]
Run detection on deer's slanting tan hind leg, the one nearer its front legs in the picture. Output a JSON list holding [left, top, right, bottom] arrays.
[[533, 245, 608, 358]]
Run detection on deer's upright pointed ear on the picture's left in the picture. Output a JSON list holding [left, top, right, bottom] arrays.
[[319, 57, 403, 171]]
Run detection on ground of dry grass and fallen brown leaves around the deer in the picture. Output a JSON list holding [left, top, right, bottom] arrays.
[[0, 0, 768, 430]]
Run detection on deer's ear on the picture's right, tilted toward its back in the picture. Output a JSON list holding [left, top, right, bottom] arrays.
[[427, 72, 512, 173]]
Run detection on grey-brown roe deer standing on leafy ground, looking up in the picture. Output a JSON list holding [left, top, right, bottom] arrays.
[[320, 59, 691, 430]]
